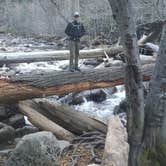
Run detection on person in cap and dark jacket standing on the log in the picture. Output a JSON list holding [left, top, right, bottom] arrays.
[[65, 12, 85, 72]]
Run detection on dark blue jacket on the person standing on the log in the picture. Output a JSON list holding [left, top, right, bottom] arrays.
[[65, 21, 85, 41]]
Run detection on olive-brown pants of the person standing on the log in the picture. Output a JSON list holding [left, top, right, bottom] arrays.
[[69, 41, 80, 69]]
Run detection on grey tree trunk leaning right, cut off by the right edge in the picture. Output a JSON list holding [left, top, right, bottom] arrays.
[[144, 24, 166, 148]]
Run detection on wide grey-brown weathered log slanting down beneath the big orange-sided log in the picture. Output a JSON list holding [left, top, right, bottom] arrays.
[[20, 99, 107, 134]]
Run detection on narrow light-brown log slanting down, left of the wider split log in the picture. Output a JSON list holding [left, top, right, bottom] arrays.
[[18, 101, 74, 141]]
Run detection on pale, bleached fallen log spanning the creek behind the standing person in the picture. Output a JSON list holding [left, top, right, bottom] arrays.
[[0, 46, 123, 65]]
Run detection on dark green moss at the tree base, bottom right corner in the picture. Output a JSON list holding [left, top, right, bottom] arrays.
[[141, 144, 166, 166]]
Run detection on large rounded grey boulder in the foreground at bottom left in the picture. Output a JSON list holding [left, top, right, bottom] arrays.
[[5, 132, 69, 166]]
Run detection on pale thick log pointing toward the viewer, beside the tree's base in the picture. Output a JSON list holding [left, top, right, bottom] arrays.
[[101, 117, 129, 166]]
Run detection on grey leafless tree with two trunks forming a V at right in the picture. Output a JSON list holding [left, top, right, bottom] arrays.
[[108, 0, 166, 166]]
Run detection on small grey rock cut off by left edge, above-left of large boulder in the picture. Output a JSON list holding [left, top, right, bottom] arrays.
[[0, 123, 15, 143]]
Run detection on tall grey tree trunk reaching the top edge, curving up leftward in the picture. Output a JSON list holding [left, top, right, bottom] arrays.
[[109, 0, 144, 166]]
